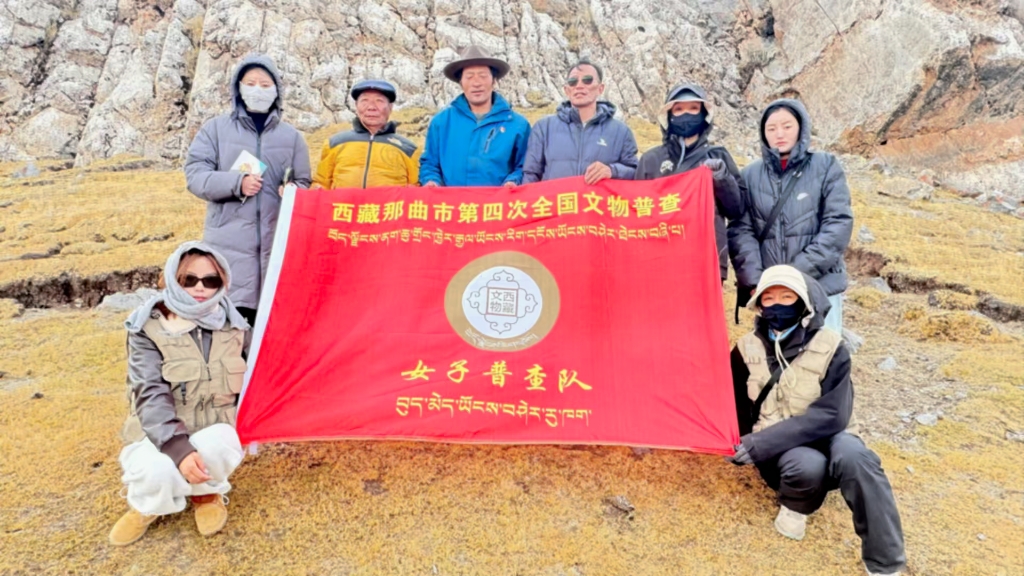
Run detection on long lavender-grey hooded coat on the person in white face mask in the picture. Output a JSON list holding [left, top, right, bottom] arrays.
[[185, 55, 311, 308]]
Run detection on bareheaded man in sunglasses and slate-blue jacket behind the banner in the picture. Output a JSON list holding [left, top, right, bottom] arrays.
[[522, 60, 637, 184]]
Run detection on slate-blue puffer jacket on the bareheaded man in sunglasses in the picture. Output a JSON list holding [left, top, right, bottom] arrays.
[[522, 101, 637, 183]]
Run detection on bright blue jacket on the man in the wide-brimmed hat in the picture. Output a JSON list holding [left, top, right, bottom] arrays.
[[420, 92, 529, 186]]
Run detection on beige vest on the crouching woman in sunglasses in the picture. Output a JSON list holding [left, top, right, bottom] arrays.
[[122, 315, 246, 443]]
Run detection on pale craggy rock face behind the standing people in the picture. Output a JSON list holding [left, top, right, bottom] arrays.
[[0, 0, 1024, 188]]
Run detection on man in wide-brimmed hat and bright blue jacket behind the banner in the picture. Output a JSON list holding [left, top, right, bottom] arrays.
[[420, 46, 529, 187]]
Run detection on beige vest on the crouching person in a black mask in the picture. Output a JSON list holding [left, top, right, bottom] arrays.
[[737, 330, 857, 434]]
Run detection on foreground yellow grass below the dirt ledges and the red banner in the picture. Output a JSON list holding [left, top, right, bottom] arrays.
[[0, 295, 1024, 575]]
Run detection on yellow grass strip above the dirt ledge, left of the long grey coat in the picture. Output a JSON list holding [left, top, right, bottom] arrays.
[[0, 159, 206, 285]]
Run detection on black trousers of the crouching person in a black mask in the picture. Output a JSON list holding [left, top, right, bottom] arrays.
[[758, 433, 906, 574]]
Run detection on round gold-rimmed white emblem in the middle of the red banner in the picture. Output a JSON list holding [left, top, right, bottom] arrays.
[[444, 251, 560, 352]]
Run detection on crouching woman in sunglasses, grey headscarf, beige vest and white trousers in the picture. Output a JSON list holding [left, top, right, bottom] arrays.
[[110, 242, 249, 546]]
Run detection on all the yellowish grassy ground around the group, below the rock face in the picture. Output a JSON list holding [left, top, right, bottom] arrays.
[[0, 121, 1024, 576]]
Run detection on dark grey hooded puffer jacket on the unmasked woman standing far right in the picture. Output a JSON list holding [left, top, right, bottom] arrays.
[[728, 99, 853, 296]]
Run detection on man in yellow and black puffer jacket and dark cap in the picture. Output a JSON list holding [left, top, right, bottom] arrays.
[[311, 80, 421, 190]]
